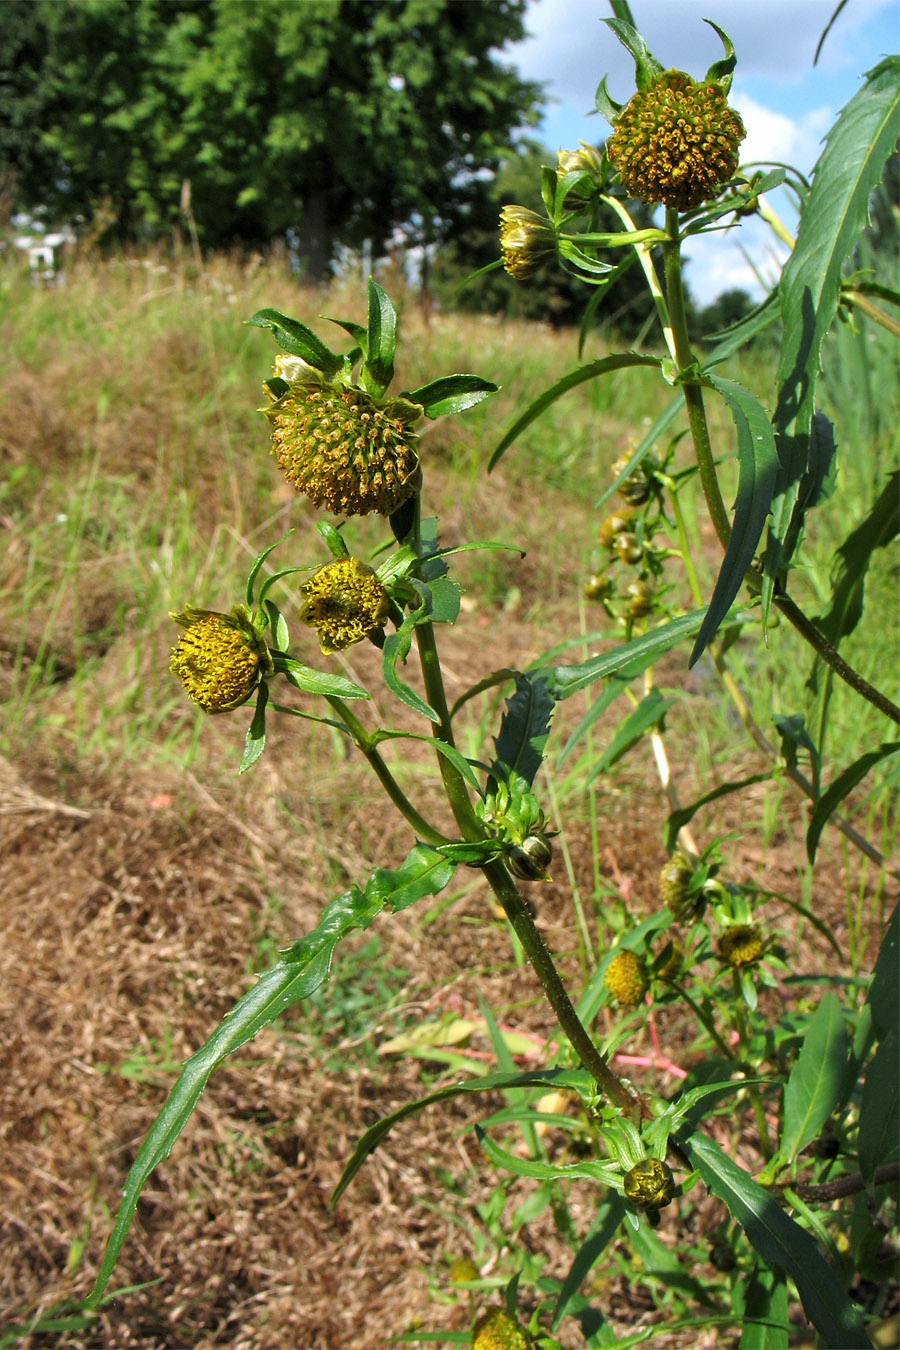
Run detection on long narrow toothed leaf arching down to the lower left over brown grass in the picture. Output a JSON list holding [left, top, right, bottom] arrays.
[[88, 844, 455, 1307]]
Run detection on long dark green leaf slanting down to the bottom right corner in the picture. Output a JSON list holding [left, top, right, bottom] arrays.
[[679, 1131, 872, 1350]]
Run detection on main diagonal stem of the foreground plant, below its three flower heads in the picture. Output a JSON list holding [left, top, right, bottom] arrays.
[[416, 624, 642, 1114]]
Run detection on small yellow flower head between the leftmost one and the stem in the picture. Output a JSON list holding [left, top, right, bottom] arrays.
[[300, 558, 390, 655]]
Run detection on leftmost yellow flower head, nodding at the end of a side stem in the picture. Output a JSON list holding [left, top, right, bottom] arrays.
[[169, 605, 273, 713]]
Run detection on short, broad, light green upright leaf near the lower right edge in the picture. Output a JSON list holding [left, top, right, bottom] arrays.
[[779, 991, 849, 1165]]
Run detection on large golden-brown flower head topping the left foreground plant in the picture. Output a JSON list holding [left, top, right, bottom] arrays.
[[263, 366, 422, 516]]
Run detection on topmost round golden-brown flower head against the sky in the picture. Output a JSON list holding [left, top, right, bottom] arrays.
[[606, 70, 746, 211]]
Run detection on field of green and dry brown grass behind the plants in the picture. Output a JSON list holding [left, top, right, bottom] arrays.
[[0, 251, 897, 1350]]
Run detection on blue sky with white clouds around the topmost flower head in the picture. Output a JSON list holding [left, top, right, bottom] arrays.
[[503, 0, 900, 304]]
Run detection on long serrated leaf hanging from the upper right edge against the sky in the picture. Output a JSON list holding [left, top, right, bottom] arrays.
[[762, 57, 900, 618]]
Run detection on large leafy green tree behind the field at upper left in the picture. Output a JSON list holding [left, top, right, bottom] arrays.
[[8, 0, 540, 274]]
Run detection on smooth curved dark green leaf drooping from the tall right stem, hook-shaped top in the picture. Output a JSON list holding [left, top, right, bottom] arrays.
[[688, 374, 779, 666]]
